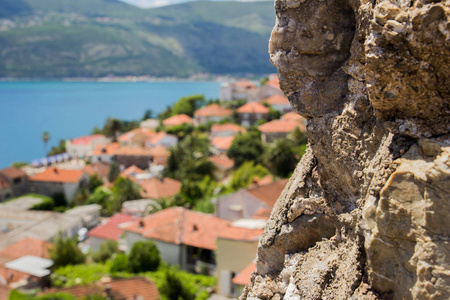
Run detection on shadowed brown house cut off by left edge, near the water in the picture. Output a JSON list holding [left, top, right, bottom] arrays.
[[0, 167, 30, 201]]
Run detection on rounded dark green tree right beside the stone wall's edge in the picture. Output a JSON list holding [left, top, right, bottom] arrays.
[[264, 139, 299, 177]]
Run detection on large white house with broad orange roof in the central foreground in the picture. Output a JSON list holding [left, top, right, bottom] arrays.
[[124, 207, 230, 273]]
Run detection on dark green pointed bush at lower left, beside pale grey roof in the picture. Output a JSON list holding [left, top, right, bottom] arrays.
[[50, 232, 86, 268]]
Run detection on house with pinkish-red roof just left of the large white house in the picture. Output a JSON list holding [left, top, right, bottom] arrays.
[[87, 213, 134, 252]]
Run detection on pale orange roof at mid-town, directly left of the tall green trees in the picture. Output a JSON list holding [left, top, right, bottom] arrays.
[[138, 177, 181, 199]]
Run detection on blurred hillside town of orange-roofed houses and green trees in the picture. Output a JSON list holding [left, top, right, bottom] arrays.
[[0, 75, 306, 299]]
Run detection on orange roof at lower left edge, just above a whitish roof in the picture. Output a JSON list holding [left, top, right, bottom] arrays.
[[0, 238, 52, 259]]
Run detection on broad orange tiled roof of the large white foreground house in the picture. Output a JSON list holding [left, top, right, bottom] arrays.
[[125, 207, 230, 250]]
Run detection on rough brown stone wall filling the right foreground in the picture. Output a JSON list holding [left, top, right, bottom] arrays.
[[241, 0, 450, 299]]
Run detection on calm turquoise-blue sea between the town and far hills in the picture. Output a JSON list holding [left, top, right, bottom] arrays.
[[0, 81, 220, 168]]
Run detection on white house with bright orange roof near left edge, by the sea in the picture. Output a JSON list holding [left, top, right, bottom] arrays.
[[30, 167, 89, 202]]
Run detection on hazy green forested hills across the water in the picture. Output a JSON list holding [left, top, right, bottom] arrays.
[[0, 0, 275, 78]]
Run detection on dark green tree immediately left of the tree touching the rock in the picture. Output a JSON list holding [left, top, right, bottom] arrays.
[[227, 131, 264, 167]]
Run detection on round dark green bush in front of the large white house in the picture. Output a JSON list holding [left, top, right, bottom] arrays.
[[128, 241, 161, 273]]
